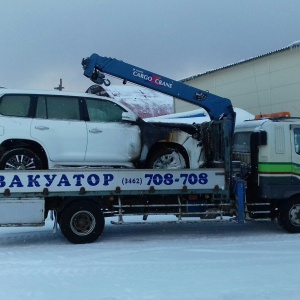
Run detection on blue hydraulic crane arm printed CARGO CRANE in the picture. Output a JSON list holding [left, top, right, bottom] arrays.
[[82, 53, 235, 124]]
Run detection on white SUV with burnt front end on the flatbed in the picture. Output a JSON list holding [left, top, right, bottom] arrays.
[[0, 89, 202, 169]]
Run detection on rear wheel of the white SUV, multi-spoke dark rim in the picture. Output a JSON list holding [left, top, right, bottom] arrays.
[[0, 148, 43, 170]]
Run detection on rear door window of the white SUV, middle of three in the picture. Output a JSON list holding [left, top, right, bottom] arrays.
[[36, 96, 80, 120]]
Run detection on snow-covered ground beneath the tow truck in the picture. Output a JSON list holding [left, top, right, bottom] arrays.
[[0, 217, 300, 300]]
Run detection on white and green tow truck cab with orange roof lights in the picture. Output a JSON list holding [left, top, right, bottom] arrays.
[[233, 117, 300, 231]]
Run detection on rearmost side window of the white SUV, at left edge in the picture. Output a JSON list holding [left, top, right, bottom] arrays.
[[0, 95, 30, 117]]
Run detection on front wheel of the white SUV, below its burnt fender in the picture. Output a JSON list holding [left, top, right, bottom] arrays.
[[148, 148, 187, 169]]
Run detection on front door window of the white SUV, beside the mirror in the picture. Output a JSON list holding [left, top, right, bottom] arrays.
[[86, 99, 124, 122]]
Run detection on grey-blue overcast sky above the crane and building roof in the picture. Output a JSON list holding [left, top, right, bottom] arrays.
[[0, 0, 300, 92]]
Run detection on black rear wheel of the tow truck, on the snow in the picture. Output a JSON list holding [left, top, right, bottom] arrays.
[[59, 200, 105, 244]]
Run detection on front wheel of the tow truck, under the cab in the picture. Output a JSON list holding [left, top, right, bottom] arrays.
[[278, 198, 300, 233]]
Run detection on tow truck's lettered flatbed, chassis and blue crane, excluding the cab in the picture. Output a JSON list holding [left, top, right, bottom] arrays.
[[0, 54, 300, 244]]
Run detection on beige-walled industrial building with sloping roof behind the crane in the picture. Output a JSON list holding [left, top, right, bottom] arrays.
[[175, 41, 300, 116]]
